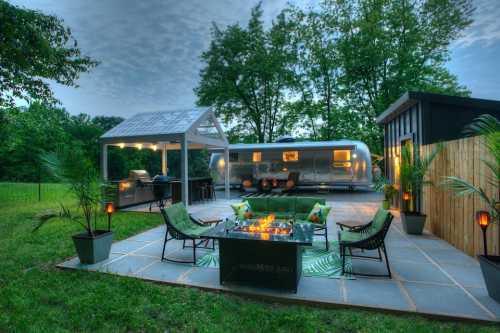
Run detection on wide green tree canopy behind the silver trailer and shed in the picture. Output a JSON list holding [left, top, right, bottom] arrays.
[[196, 0, 474, 152]]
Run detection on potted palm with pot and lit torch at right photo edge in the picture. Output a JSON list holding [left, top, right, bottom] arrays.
[[444, 115, 500, 303]]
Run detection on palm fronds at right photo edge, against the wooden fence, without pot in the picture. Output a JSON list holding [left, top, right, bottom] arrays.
[[443, 114, 500, 221]]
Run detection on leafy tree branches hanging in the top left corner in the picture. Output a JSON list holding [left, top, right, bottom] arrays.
[[0, 0, 97, 107]]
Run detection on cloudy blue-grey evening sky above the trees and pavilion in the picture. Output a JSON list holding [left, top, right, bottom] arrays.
[[10, 0, 500, 117]]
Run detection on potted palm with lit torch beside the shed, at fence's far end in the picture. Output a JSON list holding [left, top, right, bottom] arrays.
[[400, 144, 442, 235]]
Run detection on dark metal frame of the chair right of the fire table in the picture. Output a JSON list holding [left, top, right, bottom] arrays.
[[339, 213, 394, 279]]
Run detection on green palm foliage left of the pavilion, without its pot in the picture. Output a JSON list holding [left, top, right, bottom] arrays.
[[37, 146, 101, 236]]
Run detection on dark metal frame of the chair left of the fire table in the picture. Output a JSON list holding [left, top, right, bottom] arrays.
[[160, 208, 215, 264]]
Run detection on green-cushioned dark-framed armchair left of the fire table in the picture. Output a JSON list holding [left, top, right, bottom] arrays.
[[160, 203, 214, 264]]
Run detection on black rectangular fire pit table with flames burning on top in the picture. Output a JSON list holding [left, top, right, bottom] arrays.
[[201, 218, 314, 292]]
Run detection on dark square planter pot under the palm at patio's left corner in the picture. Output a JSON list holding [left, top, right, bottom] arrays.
[[73, 230, 113, 264]]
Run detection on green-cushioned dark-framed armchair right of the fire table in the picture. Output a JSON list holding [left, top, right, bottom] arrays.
[[338, 208, 393, 278]]
